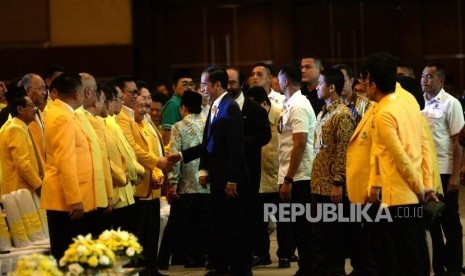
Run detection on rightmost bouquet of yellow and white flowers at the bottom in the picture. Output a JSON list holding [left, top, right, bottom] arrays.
[[98, 228, 142, 272]]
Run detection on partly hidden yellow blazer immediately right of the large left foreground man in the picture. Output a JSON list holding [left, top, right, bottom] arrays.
[[76, 106, 113, 208]]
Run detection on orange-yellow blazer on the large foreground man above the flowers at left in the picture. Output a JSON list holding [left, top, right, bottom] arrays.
[[41, 99, 97, 212]]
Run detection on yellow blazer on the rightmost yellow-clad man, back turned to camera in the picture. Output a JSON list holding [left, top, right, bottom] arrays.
[[369, 94, 424, 206]]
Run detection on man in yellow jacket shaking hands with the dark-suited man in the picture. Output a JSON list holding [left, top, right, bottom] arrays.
[[117, 74, 171, 275]]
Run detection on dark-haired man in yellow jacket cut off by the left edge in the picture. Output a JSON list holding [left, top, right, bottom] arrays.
[[0, 88, 44, 195]]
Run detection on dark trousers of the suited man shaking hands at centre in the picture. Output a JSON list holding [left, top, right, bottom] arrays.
[[211, 190, 252, 276]]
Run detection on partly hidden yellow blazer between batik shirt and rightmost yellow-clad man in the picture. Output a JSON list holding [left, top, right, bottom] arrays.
[[346, 103, 376, 204]]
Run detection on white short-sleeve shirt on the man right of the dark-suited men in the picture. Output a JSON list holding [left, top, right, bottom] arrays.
[[278, 90, 316, 184]]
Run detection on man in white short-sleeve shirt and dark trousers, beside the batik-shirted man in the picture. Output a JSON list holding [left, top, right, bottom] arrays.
[[278, 65, 316, 275]]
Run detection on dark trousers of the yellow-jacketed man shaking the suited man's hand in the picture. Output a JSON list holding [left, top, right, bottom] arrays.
[[132, 197, 160, 274]]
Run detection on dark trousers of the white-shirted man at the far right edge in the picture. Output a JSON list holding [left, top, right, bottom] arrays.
[[430, 174, 463, 274]]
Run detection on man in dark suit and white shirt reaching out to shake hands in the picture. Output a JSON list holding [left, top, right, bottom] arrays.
[[169, 67, 252, 276]]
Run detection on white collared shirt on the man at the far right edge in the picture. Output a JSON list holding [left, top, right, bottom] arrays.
[[421, 88, 464, 174]]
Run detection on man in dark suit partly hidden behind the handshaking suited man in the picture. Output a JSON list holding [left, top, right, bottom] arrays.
[[226, 67, 271, 266]]
